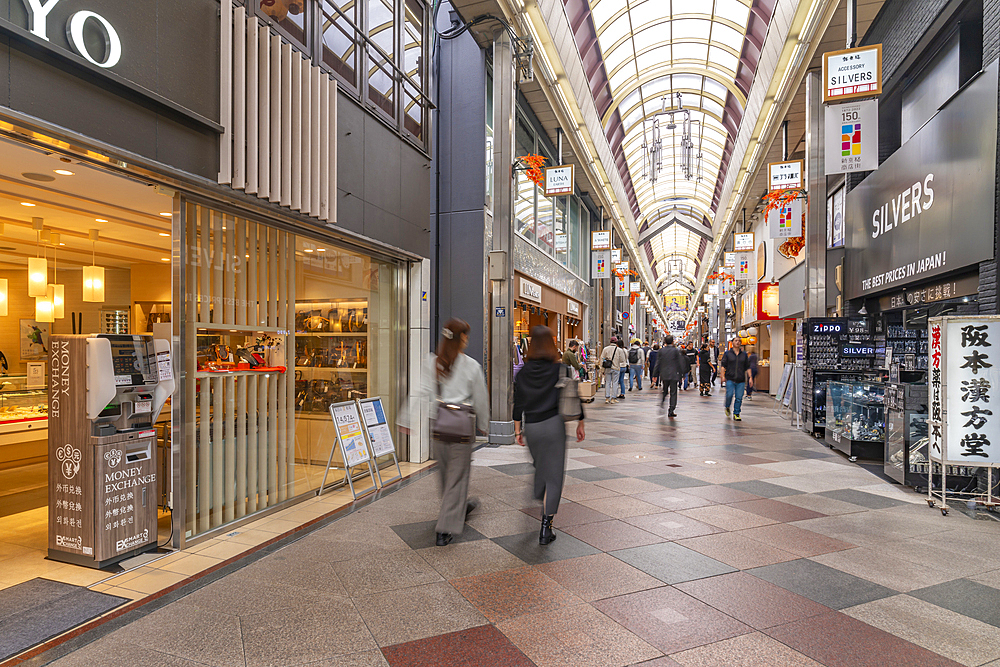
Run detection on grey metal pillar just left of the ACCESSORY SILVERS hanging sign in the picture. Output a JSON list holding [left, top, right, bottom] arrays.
[[805, 72, 826, 317]]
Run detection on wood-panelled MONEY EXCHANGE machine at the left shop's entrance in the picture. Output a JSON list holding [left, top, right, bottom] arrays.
[[48, 334, 174, 568]]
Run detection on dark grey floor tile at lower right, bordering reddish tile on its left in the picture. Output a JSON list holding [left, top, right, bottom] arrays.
[[747, 558, 896, 609]]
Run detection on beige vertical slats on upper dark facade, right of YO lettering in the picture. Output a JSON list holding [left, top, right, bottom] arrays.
[[219, 0, 337, 222]]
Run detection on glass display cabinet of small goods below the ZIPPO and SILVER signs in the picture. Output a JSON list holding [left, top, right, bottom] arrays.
[[825, 381, 885, 461]]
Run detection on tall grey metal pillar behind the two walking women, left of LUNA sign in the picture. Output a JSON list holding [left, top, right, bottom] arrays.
[[488, 30, 516, 445]]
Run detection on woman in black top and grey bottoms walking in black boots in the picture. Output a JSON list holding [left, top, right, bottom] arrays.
[[514, 326, 586, 545]]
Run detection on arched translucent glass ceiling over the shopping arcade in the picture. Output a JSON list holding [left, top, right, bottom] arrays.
[[580, 0, 773, 292]]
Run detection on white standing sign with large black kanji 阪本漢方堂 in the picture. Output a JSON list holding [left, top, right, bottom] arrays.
[[930, 317, 1000, 466]]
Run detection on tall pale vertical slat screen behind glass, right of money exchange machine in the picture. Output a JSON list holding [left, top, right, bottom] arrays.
[[184, 202, 295, 537]]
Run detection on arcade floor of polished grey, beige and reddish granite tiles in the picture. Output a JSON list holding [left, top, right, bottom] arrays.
[[35, 390, 1000, 667]]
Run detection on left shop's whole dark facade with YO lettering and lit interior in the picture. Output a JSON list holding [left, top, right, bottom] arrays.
[[0, 0, 430, 576]]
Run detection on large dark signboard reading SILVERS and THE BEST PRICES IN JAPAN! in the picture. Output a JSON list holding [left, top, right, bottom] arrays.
[[844, 62, 998, 299]]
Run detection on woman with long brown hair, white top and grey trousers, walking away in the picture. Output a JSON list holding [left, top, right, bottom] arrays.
[[423, 318, 490, 547]]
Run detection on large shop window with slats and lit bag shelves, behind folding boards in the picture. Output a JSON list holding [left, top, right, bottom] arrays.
[[180, 202, 405, 538]]
